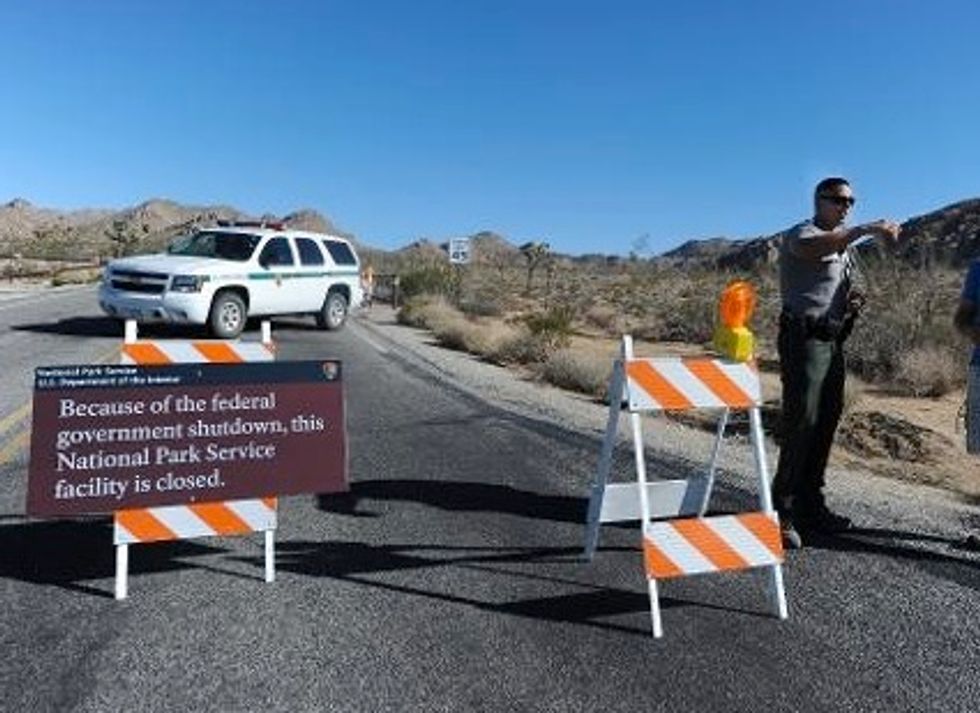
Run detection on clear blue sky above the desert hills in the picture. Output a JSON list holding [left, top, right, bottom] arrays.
[[0, 0, 980, 254]]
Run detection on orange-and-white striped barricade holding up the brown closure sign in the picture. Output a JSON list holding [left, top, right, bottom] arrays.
[[113, 320, 277, 599]]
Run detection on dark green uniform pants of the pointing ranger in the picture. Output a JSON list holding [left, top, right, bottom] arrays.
[[772, 316, 844, 517]]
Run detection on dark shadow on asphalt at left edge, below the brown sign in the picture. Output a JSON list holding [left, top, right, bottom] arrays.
[[0, 519, 242, 598]]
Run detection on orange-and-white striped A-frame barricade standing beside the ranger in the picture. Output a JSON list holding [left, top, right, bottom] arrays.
[[585, 336, 787, 638]]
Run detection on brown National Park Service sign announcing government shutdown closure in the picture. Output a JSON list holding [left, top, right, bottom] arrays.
[[27, 361, 347, 516]]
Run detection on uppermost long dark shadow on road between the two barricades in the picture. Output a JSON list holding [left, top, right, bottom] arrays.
[[317, 480, 588, 523]]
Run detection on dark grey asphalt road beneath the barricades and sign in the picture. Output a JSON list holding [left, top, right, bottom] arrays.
[[0, 290, 980, 712]]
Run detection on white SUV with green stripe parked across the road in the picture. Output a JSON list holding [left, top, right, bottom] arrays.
[[99, 222, 363, 339]]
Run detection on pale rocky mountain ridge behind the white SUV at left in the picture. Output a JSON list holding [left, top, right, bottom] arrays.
[[0, 198, 352, 260]]
